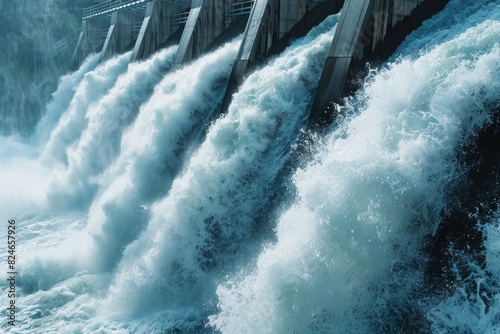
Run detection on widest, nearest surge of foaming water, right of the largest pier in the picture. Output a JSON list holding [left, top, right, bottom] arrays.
[[210, 4, 500, 333]]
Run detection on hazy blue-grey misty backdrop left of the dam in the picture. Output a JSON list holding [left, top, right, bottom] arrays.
[[0, 0, 97, 137]]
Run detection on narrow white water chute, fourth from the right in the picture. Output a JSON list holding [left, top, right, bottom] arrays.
[[44, 47, 177, 208]]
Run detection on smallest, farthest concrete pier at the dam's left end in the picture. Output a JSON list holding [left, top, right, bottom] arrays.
[[71, 19, 101, 68]]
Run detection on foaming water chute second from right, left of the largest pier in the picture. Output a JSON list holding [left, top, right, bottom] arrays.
[[104, 13, 337, 320]]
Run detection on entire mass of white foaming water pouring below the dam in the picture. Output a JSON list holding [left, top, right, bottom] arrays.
[[0, 0, 500, 333]]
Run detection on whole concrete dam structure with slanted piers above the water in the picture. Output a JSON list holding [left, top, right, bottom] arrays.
[[72, 0, 448, 124]]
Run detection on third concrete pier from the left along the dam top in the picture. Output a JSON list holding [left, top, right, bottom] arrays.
[[130, 0, 186, 62]]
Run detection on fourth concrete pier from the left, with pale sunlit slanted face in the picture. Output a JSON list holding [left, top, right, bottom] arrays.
[[175, 0, 226, 64]]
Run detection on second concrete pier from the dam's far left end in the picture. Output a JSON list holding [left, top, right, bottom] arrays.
[[99, 11, 134, 62]]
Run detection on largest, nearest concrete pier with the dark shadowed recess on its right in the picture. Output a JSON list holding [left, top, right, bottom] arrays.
[[311, 0, 449, 124]]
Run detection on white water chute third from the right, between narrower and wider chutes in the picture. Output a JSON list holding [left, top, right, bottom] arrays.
[[84, 37, 239, 270]]
